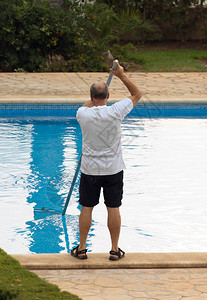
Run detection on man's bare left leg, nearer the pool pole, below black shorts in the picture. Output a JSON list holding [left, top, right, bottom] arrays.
[[78, 206, 93, 251]]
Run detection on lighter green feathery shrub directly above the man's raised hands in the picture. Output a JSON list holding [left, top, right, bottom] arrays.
[[73, 2, 154, 65]]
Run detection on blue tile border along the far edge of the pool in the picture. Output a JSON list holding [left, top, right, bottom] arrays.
[[0, 103, 207, 118]]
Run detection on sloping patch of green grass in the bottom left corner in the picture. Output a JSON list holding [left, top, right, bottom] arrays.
[[0, 249, 80, 300]]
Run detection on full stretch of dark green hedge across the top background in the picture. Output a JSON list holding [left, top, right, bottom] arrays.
[[0, 0, 207, 72]]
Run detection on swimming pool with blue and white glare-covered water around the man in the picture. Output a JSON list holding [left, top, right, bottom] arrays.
[[0, 106, 207, 253]]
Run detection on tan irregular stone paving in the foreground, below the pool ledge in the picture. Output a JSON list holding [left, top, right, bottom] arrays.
[[33, 268, 207, 300]]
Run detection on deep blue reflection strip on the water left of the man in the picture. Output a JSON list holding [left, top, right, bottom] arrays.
[[26, 120, 80, 253]]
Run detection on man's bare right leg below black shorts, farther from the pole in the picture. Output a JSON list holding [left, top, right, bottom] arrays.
[[107, 207, 121, 252]]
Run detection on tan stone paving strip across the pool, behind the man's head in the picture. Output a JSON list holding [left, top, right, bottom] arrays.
[[0, 72, 207, 103]]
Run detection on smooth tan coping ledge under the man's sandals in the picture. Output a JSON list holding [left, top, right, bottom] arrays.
[[11, 252, 207, 270]]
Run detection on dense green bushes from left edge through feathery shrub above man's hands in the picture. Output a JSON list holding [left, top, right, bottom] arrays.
[[0, 0, 153, 72]]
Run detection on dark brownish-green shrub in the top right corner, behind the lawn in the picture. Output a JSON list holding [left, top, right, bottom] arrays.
[[136, 0, 206, 41]]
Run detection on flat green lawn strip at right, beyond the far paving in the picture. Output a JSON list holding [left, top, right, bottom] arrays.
[[127, 50, 207, 72]]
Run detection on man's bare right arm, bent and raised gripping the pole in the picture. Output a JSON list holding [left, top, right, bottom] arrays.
[[112, 64, 142, 106]]
